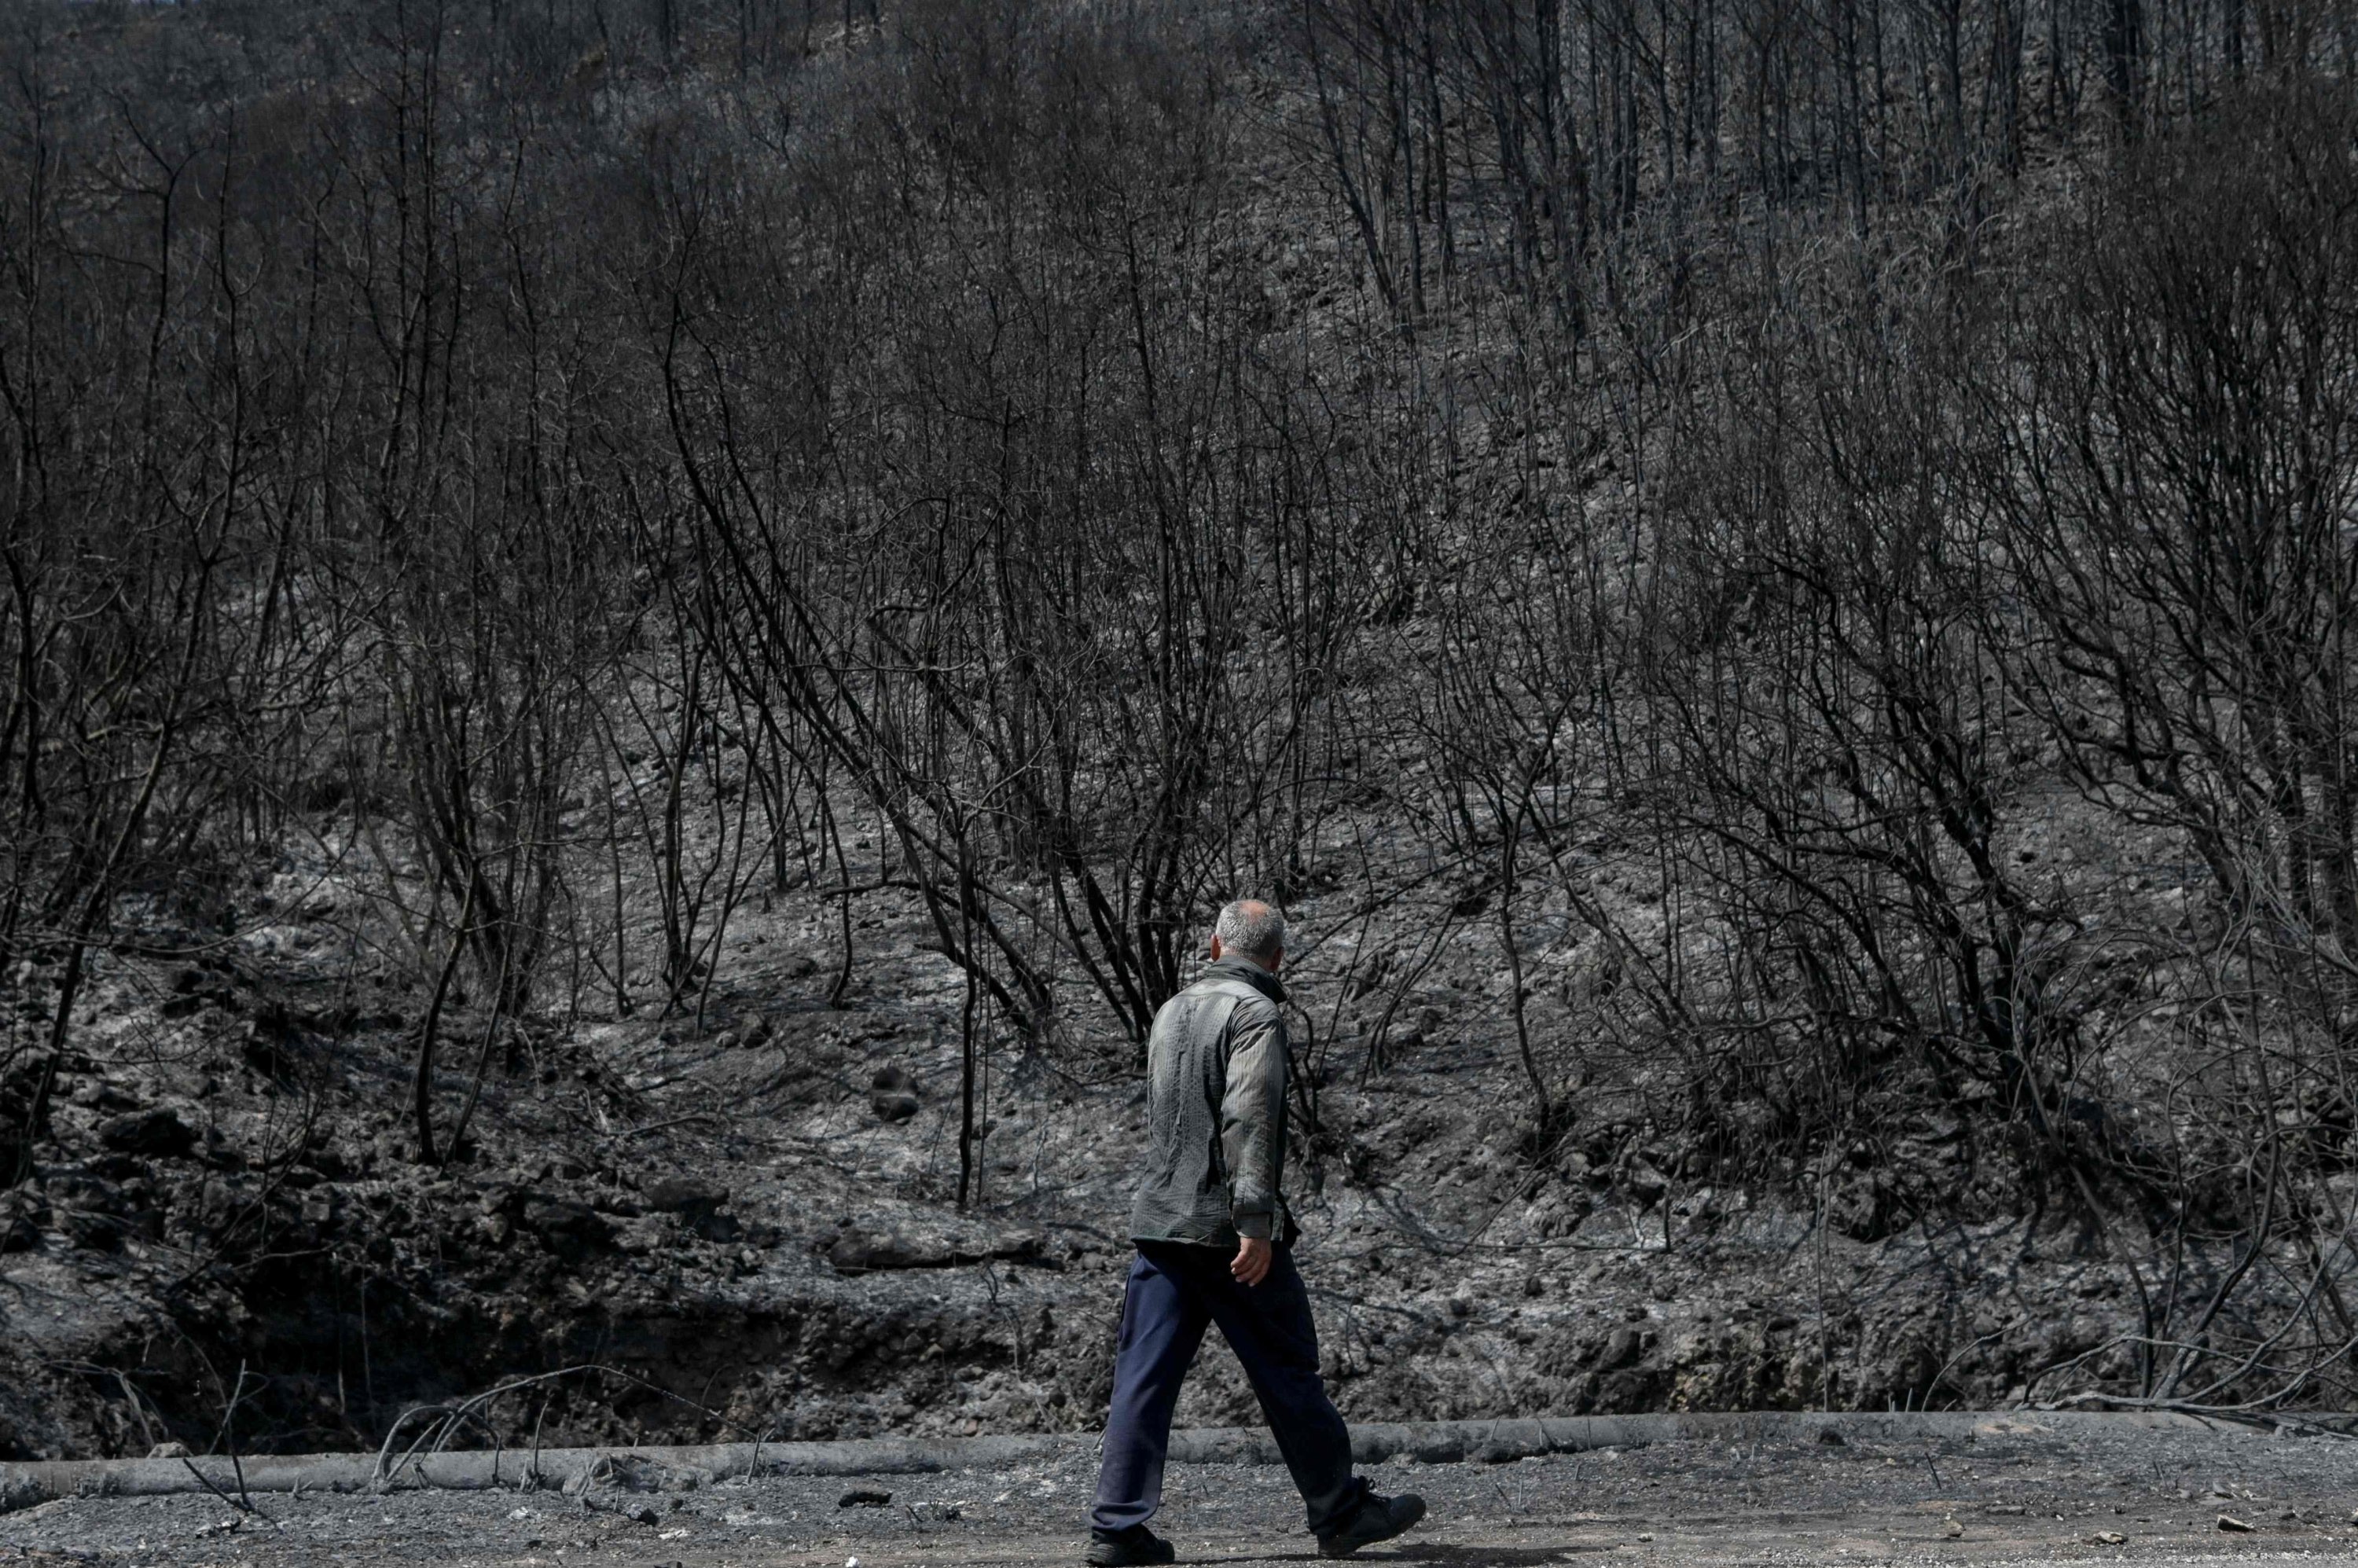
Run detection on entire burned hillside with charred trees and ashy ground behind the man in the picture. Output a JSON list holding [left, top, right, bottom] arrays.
[[0, 0, 2358, 1455]]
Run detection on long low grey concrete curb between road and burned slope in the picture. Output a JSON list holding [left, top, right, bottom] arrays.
[[0, 1410, 2257, 1514]]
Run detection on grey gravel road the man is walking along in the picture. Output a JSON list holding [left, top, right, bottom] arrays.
[[0, 1417, 2358, 1568]]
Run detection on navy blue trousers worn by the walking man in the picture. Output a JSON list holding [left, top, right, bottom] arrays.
[[1089, 1240, 1368, 1535]]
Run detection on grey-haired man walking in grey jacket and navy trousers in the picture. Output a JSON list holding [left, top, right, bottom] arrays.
[[1089, 898, 1424, 1568]]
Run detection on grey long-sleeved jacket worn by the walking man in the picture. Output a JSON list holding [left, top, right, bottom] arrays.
[[1129, 957, 1290, 1247]]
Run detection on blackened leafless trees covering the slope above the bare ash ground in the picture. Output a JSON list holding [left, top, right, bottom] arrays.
[[0, 0, 2358, 1405]]
